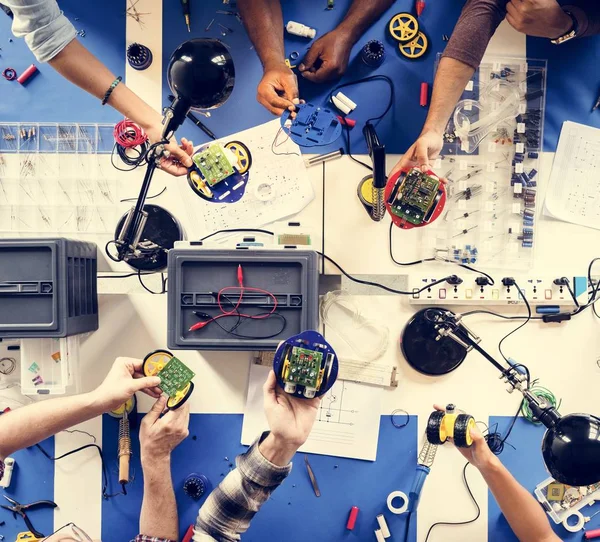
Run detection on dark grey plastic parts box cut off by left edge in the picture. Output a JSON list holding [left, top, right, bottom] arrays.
[[0, 238, 98, 339]]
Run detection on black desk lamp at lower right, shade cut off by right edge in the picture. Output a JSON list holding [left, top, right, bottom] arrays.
[[405, 309, 600, 486]]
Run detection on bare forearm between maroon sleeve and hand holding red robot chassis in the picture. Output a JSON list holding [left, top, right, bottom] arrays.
[[423, 58, 475, 134]]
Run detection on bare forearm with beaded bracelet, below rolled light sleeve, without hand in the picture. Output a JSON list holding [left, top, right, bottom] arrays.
[[49, 40, 161, 129]]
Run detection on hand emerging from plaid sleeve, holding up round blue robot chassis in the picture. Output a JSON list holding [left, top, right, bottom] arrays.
[[260, 371, 321, 465]]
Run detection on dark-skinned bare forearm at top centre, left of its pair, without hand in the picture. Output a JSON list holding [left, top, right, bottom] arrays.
[[238, 0, 285, 68]]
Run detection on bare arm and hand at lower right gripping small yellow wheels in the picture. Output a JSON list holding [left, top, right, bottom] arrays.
[[452, 418, 560, 542]]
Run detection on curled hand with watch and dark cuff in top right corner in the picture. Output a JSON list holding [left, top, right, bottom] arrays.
[[506, 0, 600, 39]]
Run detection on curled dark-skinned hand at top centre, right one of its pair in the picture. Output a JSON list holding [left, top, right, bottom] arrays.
[[298, 29, 353, 83]]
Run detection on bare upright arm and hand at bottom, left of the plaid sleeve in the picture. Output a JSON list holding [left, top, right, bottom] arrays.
[[136, 397, 190, 542]]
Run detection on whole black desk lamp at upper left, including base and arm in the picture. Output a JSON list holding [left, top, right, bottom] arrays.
[[107, 39, 235, 270]]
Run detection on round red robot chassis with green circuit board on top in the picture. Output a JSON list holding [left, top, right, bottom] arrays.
[[388, 168, 440, 226]]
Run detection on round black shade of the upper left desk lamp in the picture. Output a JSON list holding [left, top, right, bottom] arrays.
[[167, 39, 235, 109]]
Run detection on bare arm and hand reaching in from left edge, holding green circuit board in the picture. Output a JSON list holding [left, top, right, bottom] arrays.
[[0, 358, 160, 460]]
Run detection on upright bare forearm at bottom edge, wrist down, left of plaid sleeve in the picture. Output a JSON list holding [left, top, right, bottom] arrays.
[[140, 457, 179, 540]]
